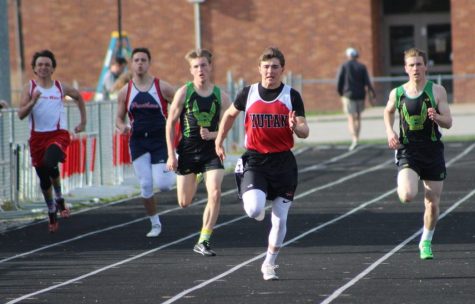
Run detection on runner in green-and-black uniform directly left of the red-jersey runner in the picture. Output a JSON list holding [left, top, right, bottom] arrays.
[[167, 49, 231, 256]]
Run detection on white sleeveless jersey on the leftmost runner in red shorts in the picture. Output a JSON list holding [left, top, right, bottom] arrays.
[[29, 80, 67, 132]]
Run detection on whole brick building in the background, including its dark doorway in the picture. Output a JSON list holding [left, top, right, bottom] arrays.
[[7, 0, 475, 111]]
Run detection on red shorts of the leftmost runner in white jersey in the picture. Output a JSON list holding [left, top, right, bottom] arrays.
[[29, 130, 71, 167]]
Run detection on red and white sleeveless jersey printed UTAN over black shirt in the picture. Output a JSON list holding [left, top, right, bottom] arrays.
[[244, 83, 294, 153]]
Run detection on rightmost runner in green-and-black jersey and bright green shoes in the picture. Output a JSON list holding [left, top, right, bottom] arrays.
[[384, 48, 452, 260]]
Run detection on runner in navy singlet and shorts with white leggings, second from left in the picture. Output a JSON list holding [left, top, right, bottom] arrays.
[[116, 48, 175, 237]]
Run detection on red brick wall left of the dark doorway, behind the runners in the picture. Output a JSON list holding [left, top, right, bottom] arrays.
[[8, 0, 438, 111]]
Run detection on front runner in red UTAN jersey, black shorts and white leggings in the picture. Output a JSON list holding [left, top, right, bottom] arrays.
[[216, 47, 309, 280]]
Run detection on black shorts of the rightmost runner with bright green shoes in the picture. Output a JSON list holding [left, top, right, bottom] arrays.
[[396, 141, 447, 181]]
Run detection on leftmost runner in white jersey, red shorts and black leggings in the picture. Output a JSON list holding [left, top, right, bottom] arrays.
[[18, 50, 86, 233]]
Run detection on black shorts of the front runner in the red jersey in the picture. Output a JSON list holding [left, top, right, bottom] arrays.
[[236, 150, 298, 201]]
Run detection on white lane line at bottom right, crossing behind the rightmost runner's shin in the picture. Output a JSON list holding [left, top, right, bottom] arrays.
[[320, 190, 475, 304]]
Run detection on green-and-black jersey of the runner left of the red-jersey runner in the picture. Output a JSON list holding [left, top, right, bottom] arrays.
[[178, 82, 221, 154]]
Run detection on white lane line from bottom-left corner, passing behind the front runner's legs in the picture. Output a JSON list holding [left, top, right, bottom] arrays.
[[6, 154, 388, 304]]
